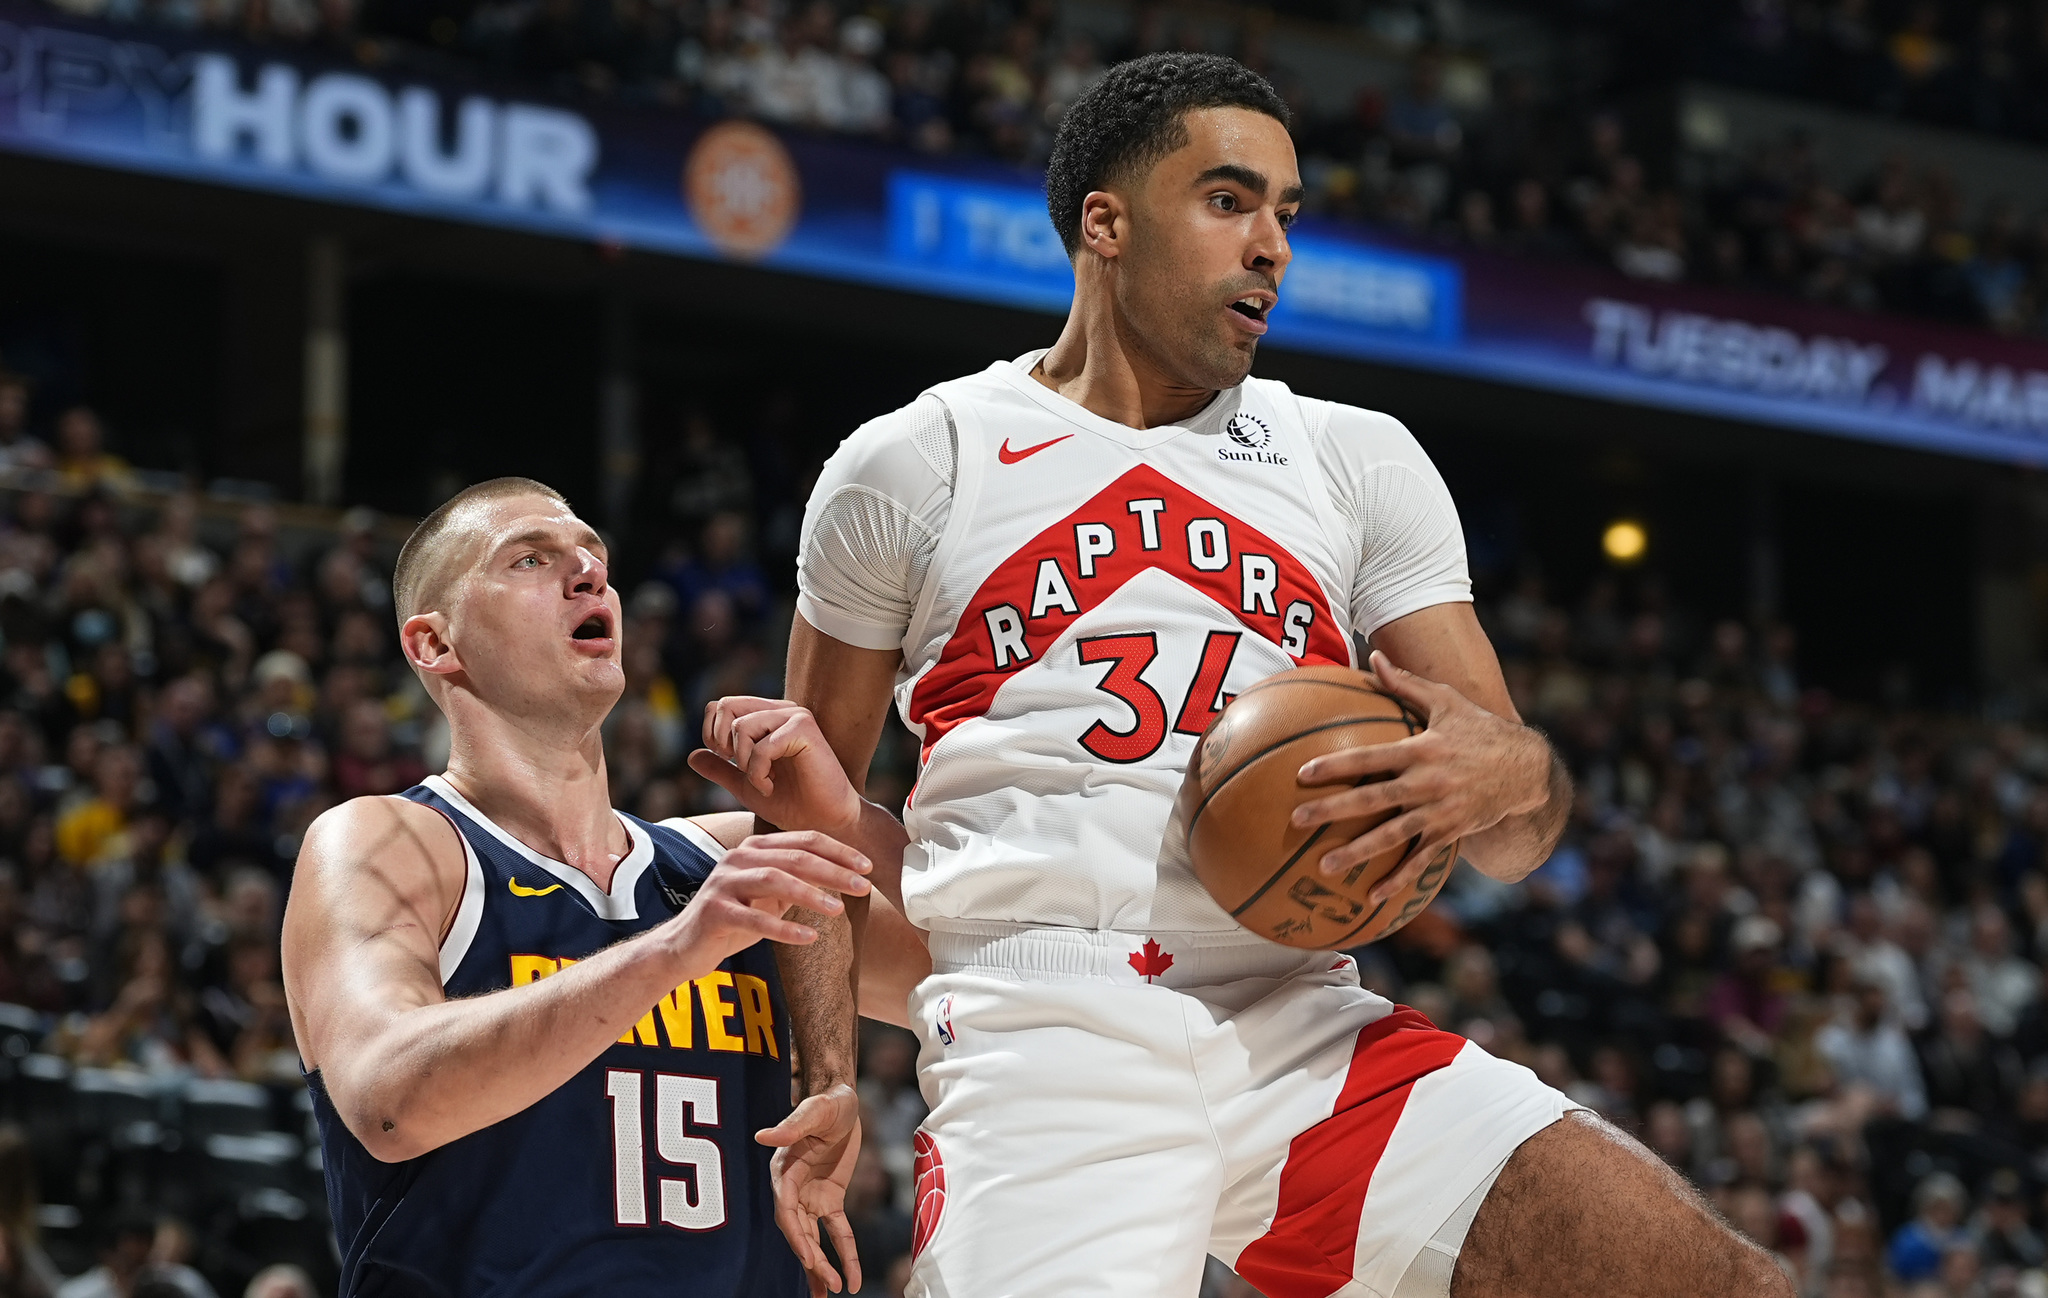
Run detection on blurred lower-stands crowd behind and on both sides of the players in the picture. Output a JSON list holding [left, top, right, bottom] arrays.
[[0, 356, 2048, 1298]]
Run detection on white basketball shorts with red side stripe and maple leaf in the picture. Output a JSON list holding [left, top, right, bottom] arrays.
[[907, 925, 1579, 1298]]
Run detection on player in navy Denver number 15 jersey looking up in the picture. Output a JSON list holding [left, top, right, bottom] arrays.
[[285, 479, 870, 1298]]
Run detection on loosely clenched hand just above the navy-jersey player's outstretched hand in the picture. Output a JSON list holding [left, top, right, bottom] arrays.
[[690, 694, 860, 833]]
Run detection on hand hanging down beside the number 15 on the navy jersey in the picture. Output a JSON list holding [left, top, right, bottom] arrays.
[[754, 1083, 860, 1298]]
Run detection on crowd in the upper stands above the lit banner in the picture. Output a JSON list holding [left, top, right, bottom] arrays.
[[32, 0, 2048, 334]]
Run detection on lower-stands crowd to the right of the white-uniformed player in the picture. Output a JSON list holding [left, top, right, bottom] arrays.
[[1362, 575, 2048, 1298]]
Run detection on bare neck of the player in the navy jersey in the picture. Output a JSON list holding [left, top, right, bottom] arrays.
[[432, 694, 633, 889]]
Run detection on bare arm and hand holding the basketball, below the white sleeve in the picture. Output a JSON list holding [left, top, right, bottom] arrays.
[[1294, 602, 1571, 901]]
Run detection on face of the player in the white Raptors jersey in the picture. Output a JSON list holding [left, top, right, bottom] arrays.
[[1116, 109, 1300, 389]]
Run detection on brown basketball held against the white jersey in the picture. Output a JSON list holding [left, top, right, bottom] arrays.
[[1180, 667, 1458, 950]]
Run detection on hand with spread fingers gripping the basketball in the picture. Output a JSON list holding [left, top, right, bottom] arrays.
[[1294, 651, 1550, 903]]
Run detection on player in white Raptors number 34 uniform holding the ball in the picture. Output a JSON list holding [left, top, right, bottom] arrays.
[[694, 55, 1790, 1298]]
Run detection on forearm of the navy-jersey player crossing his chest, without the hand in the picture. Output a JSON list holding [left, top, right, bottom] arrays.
[[322, 929, 696, 1163]]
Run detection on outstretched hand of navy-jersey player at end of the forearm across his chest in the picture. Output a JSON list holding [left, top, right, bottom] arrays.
[[674, 829, 874, 970]]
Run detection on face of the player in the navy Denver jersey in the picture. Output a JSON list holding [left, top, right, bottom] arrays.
[[449, 495, 625, 715]]
